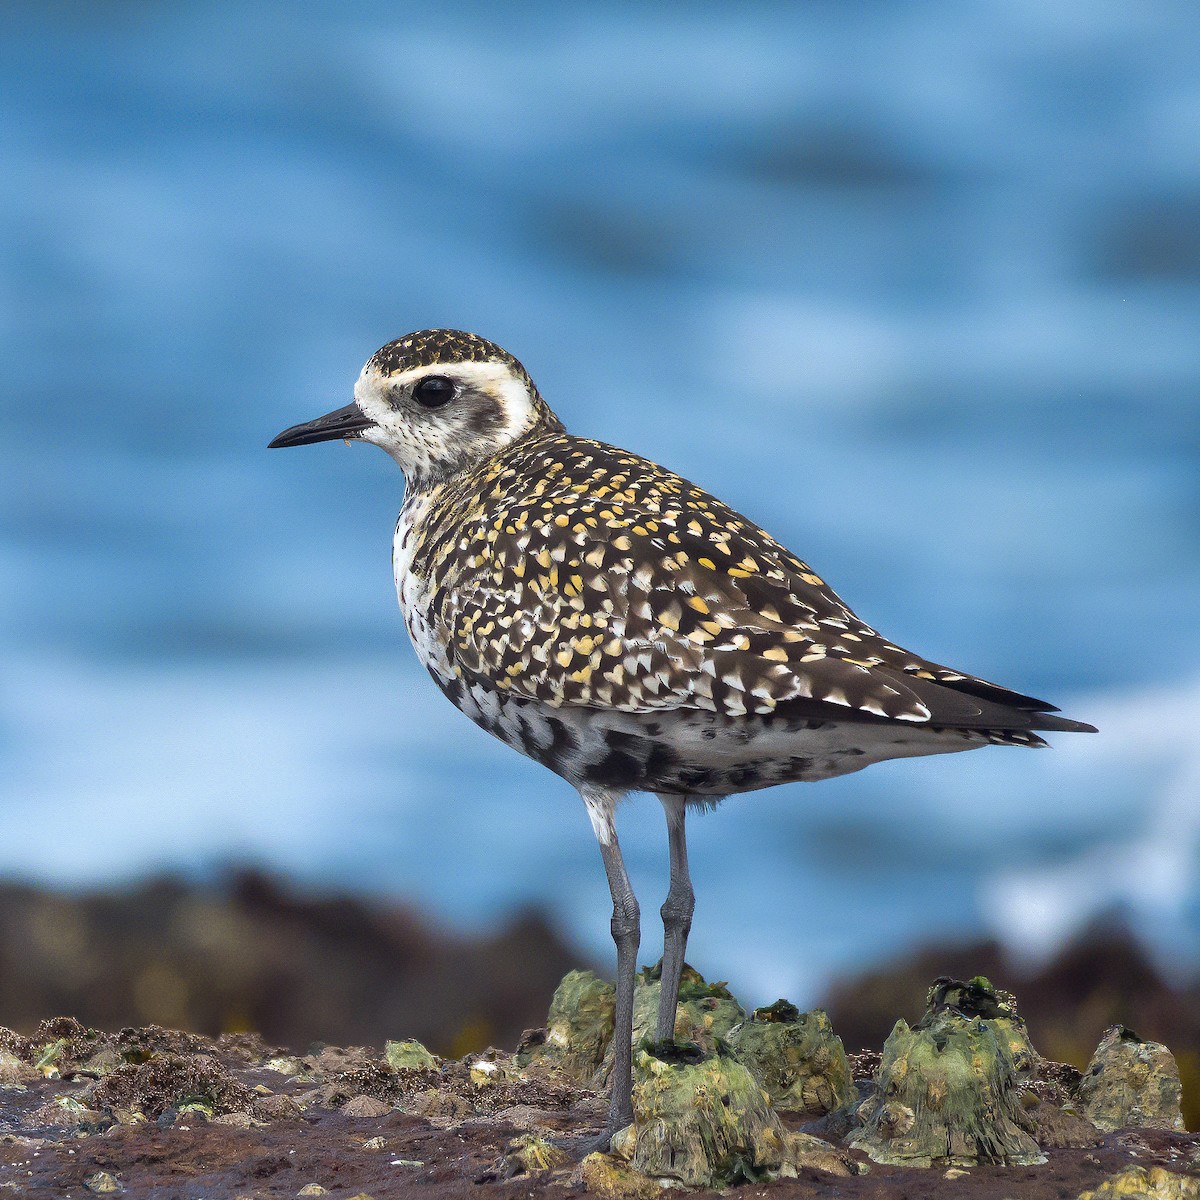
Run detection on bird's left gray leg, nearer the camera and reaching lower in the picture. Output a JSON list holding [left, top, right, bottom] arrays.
[[580, 787, 641, 1148]]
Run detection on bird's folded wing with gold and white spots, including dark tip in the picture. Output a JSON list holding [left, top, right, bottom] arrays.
[[434, 460, 1038, 726]]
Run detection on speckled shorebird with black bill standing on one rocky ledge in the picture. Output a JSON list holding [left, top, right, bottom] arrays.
[[270, 329, 1094, 1145]]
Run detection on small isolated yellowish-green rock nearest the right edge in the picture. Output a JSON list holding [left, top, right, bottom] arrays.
[[1079, 1025, 1183, 1133]]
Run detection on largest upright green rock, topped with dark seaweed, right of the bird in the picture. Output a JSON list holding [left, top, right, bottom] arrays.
[[848, 1008, 1045, 1166]]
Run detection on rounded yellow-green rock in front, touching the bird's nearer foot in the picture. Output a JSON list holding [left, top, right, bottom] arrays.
[[632, 1043, 786, 1188]]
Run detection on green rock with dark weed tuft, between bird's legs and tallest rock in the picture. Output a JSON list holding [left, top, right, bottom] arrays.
[[728, 1000, 856, 1112]]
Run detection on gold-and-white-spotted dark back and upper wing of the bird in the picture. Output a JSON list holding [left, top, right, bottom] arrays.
[[413, 432, 1003, 722]]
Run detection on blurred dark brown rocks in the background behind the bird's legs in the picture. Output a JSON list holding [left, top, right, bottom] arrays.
[[0, 870, 1200, 1089]]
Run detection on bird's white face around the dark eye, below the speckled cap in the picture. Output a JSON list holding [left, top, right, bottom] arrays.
[[354, 360, 539, 481]]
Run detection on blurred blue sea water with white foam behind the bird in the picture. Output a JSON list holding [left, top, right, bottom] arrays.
[[0, 0, 1200, 1001]]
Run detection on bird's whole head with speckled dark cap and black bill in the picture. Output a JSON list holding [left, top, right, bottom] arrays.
[[271, 329, 562, 484]]
